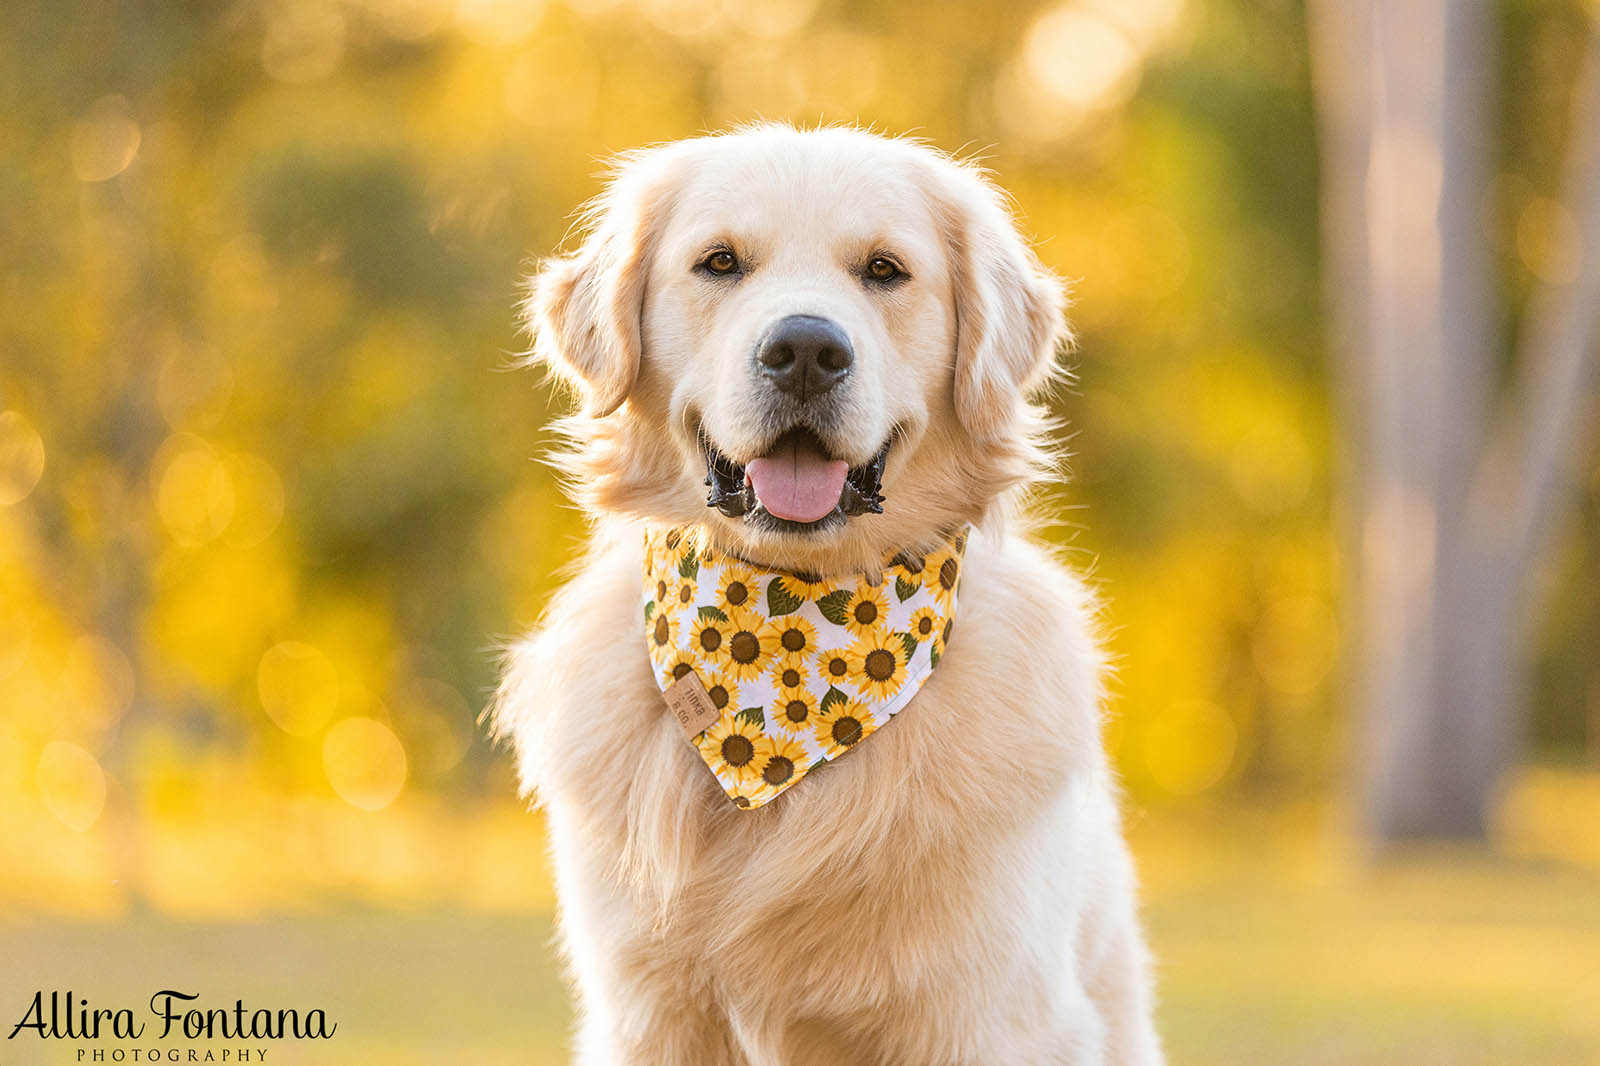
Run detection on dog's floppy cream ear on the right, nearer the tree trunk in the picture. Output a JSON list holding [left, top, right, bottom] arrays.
[[938, 162, 1072, 442]]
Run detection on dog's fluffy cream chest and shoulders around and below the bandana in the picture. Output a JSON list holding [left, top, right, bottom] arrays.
[[501, 525, 1152, 1063]]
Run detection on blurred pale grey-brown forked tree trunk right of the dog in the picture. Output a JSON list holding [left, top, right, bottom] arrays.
[[1310, 0, 1600, 844]]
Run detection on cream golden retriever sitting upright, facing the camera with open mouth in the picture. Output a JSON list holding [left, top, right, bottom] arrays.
[[494, 125, 1162, 1066]]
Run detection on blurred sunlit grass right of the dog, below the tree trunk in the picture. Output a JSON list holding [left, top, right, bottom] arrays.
[[1130, 806, 1600, 1066]]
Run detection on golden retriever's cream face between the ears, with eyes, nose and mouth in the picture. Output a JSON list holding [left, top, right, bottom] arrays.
[[643, 138, 955, 536]]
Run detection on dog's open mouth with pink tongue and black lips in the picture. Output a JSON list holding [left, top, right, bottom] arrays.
[[701, 427, 890, 530]]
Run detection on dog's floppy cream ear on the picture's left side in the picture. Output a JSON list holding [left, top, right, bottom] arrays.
[[523, 150, 667, 418]]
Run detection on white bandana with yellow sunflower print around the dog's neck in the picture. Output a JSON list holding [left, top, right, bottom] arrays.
[[643, 527, 968, 808]]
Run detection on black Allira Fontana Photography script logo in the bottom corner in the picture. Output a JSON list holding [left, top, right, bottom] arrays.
[[6, 989, 339, 1063]]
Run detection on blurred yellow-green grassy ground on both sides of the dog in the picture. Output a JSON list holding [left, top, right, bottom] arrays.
[[0, 787, 1600, 1066]]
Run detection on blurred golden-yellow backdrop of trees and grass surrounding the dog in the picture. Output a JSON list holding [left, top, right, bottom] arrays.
[[0, 0, 1600, 1066]]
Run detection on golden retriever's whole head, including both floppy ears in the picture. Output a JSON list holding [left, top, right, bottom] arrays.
[[526, 126, 1066, 573]]
